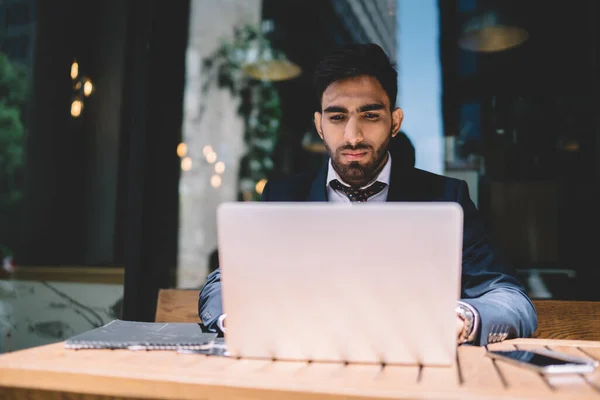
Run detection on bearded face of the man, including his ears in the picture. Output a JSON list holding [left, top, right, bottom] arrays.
[[315, 76, 403, 187]]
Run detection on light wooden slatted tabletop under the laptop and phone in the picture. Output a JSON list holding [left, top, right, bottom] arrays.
[[0, 339, 600, 399]]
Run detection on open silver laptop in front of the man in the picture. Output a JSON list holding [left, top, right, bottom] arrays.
[[217, 202, 463, 365]]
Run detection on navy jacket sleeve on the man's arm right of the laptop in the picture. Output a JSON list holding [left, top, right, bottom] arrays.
[[457, 181, 537, 346]]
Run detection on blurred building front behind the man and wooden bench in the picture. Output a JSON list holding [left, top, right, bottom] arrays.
[[0, 0, 600, 352]]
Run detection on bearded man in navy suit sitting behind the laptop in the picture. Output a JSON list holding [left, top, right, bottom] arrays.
[[198, 44, 537, 345]]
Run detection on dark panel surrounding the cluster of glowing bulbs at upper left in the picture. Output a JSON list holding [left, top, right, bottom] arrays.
[[22, 0, 128, 265]]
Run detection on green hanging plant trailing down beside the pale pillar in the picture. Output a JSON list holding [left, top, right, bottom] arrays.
[[200, 25, 281, 200]]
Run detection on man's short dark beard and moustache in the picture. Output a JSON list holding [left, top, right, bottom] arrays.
[[325, 135, 391, 188]]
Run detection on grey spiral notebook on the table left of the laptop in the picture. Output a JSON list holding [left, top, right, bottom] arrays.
[[65, 319, 217, 350]]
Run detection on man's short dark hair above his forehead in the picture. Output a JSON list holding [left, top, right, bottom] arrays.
[[314, 43, 398, 109]]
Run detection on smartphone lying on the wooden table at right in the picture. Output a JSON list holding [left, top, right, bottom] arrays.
[[487, 349, 598, 374]]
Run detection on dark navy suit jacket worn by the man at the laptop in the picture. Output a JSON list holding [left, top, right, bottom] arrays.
[[198, 158, 537, 345]]
